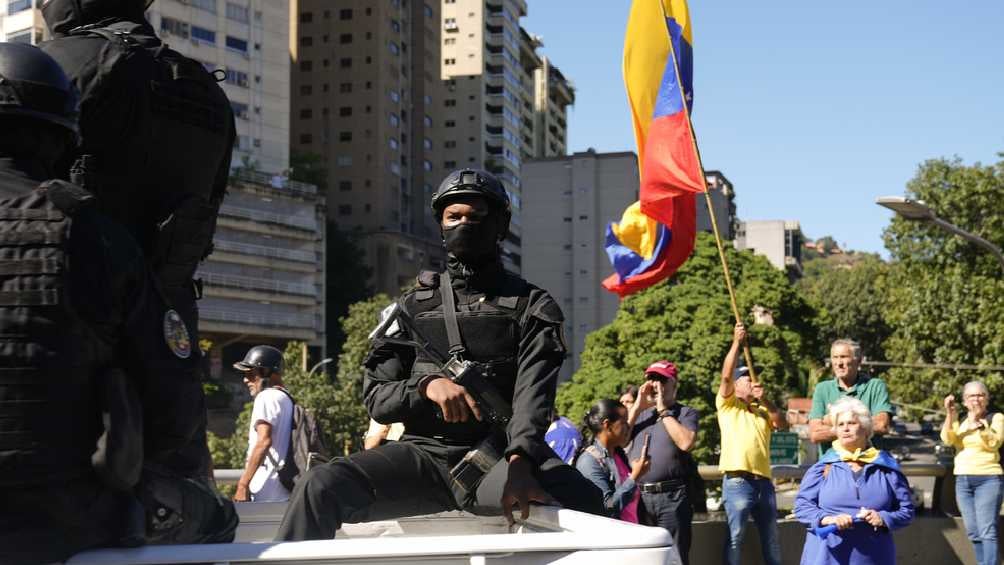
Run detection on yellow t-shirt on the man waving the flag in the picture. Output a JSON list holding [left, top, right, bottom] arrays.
[[715, 394, 771, 478]]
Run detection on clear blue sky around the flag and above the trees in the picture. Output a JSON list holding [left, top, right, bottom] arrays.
[[523, 0, 1004, 252]]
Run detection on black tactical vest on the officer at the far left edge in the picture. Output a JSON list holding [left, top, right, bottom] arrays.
[[0, 183, 110, 487]]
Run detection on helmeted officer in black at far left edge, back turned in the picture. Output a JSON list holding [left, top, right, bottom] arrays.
[[0, 43, 236, 564]]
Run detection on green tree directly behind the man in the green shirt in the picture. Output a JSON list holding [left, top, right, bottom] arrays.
[[798, 254, 892, 360]]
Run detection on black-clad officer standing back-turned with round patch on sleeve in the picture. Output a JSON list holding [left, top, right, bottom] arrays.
[[41, 0, 235, 478]]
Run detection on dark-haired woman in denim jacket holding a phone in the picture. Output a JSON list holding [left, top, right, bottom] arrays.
[[575, 398, 651, 524]]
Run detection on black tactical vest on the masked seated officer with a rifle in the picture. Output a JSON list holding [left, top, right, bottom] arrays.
[[402, 273, 531, 443]]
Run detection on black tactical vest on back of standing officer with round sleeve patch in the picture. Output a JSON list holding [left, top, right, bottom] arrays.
[[42, 21, 234, 328]]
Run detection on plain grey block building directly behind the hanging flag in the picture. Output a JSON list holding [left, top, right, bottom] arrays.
[[522, 150, 736, 381]]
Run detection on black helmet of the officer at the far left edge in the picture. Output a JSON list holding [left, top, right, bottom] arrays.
[[0, 43, 79, 133]]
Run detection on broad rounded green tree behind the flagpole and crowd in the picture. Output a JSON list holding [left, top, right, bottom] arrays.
[[557, 233, 819, 463]]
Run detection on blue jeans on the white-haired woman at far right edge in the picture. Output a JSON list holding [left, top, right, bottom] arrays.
[[955, 475, 1004, 565]]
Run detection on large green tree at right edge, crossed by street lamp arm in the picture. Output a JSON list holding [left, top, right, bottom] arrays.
[[885, 159, 1004, 413]]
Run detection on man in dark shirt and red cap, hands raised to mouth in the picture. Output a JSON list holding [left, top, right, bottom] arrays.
[[628, 361, 698, 565]]
